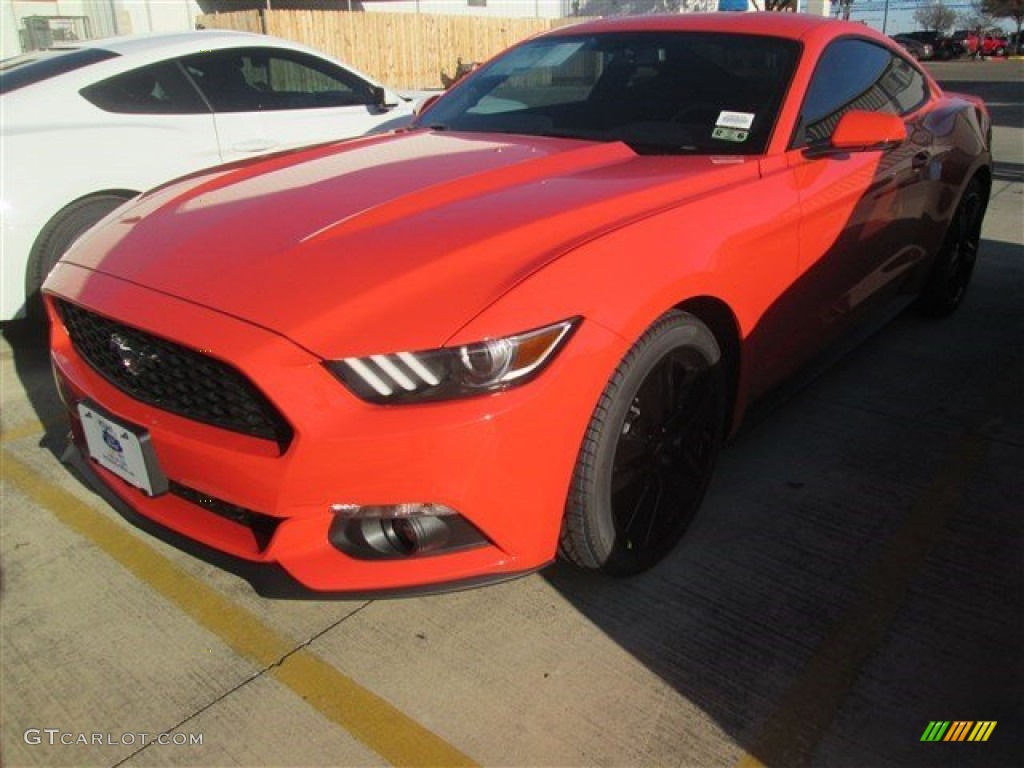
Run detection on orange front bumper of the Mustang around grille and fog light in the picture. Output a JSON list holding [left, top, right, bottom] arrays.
[[47, 264, 625, 594]]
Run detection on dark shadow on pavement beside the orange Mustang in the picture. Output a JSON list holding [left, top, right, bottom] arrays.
[[545, 241, 1024, 768]]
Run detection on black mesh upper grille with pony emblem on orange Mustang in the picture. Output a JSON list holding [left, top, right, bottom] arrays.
[[57, 301, 292, 451]]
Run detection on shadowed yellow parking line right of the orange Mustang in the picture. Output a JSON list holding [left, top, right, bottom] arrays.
[[736, 434, 987, 768]]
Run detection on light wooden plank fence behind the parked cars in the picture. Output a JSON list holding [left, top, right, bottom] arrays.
[[199, 10, 584, 88]]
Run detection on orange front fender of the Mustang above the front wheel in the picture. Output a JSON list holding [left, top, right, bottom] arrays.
[[447, 164, 800, 423]]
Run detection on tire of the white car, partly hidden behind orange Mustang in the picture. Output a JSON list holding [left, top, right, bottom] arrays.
[[25, 194, 131, 322]]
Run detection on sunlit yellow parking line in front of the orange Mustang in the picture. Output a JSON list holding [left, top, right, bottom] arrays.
[[0, 450, 475, 766]]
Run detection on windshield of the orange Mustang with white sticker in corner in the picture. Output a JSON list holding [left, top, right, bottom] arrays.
[[417, 32, 799, 155]]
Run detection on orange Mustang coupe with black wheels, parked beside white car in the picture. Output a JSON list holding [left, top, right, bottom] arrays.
[[45, 13, 991, 594]]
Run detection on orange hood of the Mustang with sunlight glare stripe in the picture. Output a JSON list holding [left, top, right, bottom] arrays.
[[65, 131, 758, 357]]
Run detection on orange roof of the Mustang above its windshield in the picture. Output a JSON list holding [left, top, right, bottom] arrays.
[[552, 12, 873, 40]]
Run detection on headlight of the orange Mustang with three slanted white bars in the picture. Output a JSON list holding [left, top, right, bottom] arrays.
[[325, 317, 580, 403]]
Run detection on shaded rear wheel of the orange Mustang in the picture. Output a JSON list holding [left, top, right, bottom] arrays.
[[918, 178, 988, 317]]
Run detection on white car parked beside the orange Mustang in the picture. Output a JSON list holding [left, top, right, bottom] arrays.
[[0, 31, 416, 319]]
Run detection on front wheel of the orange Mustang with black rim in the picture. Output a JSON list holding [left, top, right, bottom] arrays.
[[559, 311, 726, 575]]
